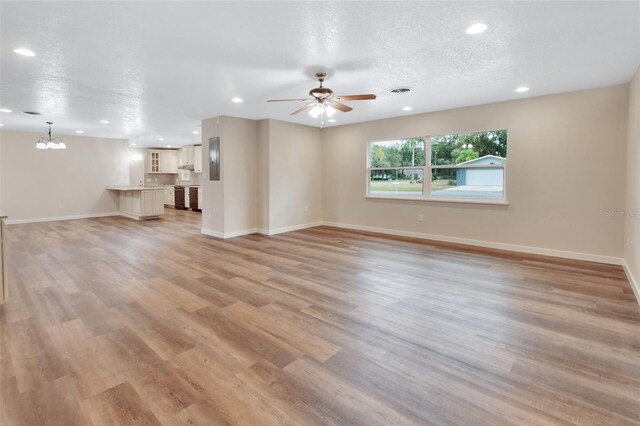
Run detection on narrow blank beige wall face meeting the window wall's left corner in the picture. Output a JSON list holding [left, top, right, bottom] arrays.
[[268, 120, 322, 232]]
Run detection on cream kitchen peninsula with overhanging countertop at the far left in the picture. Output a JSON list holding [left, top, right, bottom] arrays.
[[107, 186, 164, 220]]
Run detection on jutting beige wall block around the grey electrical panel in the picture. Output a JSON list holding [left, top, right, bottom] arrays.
[[202, 117, 322, 237]]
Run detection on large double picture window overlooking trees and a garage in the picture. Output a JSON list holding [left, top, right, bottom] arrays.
[[367, 130, 507, 202]]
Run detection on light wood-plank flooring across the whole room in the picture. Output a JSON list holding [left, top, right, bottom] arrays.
[[0, 209, 640, 426]]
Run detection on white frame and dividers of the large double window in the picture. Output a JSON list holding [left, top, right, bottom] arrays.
[[365, 133, 509, 205]]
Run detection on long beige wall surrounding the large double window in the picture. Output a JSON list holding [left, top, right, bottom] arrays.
[[322, 85, 628, 260]]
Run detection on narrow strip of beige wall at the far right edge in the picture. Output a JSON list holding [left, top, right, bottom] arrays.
[[624, 69, 640, 301]]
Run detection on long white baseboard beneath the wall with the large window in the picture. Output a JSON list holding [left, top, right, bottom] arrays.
[[323, 222, 623, 265]]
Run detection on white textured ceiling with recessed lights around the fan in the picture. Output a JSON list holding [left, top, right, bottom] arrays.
[[0, 1, 640, 146]]
